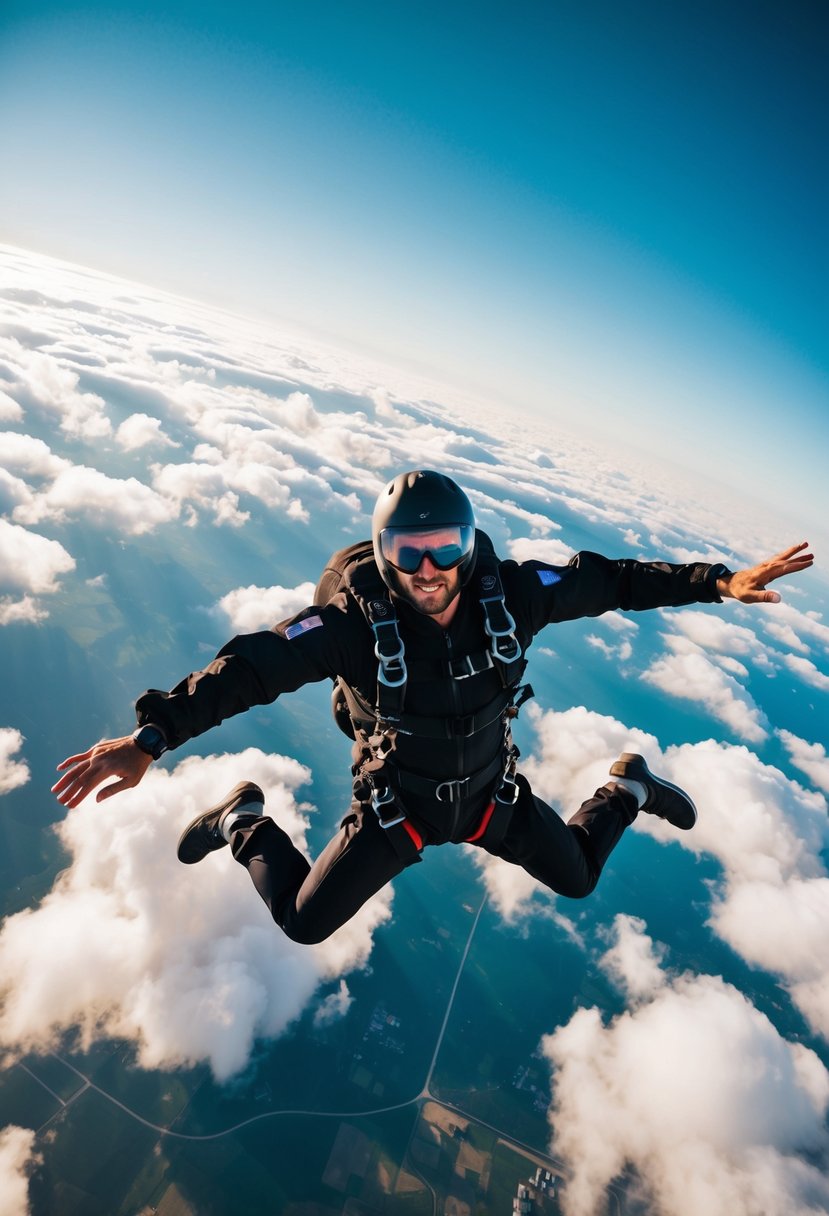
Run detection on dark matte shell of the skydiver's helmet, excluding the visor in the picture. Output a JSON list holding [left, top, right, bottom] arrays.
[[371, 468, 478, 591]]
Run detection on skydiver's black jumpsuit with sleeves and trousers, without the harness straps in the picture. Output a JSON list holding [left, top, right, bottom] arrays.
[[136, 552, 720, 942]]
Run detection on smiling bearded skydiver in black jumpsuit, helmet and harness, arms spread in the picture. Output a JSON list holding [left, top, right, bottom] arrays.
[[53, 471, 813, 942]]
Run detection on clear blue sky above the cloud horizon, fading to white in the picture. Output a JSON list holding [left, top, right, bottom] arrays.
[[0, 0, 829, 544]]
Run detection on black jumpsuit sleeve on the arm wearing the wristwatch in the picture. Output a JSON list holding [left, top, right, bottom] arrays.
[[135, 602, 360, 749]]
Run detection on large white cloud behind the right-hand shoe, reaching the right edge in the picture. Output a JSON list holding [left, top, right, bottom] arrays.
[[519, 705, 829, 1038]]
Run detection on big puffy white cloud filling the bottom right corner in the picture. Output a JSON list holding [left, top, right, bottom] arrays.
[[542, 919, 829, 1216]]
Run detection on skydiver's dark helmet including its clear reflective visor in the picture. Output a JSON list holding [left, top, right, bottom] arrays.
[[372, 469, 478, 590]]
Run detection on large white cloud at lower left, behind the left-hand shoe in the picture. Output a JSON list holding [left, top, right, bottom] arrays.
[[0, 749, 391, 1080]]
